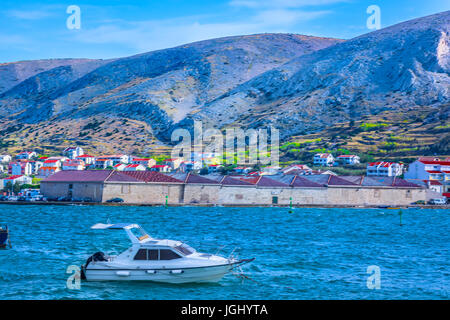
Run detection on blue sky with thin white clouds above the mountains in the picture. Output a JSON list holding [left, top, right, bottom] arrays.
[[0, 0, 450, 62]]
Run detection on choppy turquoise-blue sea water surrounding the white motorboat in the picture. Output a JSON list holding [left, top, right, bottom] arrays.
[[0, 205, 450, 299]]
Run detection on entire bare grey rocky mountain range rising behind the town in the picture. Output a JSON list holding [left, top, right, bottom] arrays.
[[0, 11, 450, 158]]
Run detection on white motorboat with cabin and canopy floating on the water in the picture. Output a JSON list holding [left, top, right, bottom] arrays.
[[81, 223, 254, 283]]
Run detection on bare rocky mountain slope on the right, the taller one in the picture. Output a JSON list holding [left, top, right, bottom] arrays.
[[192, 11, 450, 138]]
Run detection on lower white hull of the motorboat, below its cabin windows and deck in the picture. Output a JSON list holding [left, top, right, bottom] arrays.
[[83, 265, 232, 283]]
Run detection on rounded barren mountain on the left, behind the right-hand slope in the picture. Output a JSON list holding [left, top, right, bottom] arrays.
[[0, 34, 342, 154]]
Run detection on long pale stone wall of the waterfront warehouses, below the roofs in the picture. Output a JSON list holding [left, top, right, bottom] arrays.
[[41, 182, 427, 206]]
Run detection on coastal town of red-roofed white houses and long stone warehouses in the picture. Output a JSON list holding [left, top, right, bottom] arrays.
[[0, 146, 450, 206]]
